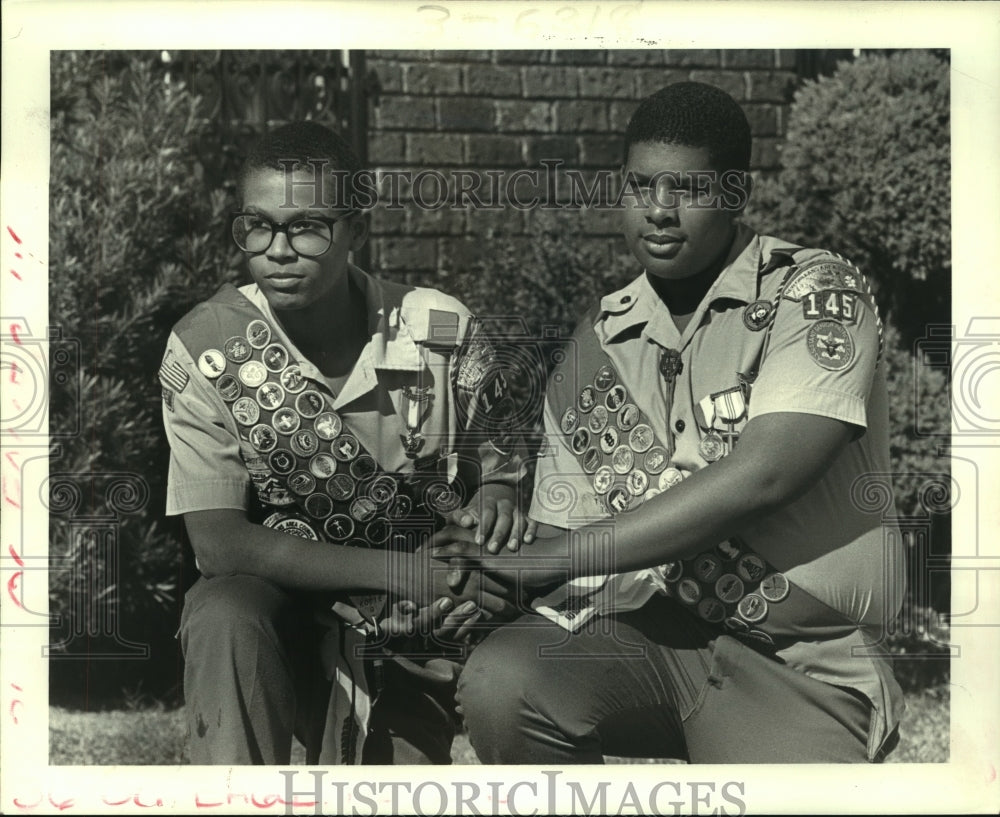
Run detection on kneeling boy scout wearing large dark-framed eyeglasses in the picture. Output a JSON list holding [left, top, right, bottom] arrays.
[[160, 123, 525, 764]]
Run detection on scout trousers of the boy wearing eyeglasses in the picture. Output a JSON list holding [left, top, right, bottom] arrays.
[[180, 575, 454, 765]]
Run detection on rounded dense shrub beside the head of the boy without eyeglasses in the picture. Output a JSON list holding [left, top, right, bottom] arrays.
[[751, 51, 951, 343]]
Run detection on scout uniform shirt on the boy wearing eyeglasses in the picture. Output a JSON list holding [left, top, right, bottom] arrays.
[[160, 266, 523, 762]]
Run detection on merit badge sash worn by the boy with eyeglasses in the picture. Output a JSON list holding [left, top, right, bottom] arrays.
[[178, 287, 465, 628]]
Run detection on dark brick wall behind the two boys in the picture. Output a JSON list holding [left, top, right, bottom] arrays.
[[366, 50, 798, 282]]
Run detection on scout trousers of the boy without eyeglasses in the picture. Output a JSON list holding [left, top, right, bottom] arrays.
[[458, 596, 871, 764]]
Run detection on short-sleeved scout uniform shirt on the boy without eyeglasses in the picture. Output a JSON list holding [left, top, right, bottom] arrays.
[[530, 225, 903, 757]]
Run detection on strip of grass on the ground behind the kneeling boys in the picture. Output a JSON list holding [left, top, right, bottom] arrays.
[[49, 685, 949, 766]]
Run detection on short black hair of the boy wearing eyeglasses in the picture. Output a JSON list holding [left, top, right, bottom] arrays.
[[236, 120, 361, 207]]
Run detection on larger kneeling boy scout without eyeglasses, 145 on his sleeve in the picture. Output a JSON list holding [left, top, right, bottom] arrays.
[[454, 83, 902, 764]]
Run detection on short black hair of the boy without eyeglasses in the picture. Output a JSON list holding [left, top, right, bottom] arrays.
[[625, 82, 752, 173]]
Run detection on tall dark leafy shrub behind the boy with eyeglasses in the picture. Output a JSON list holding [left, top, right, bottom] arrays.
[[49, 51, 236, 706]]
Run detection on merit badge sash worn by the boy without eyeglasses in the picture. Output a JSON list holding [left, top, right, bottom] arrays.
[[534, 332, 799, 645]]
